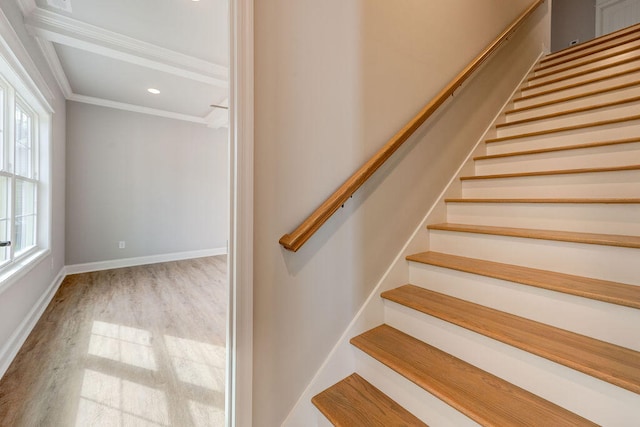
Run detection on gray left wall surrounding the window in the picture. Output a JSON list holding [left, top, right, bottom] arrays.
[[0, 1, 66, 375]]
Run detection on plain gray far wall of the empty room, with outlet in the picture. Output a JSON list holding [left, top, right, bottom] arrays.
[[66, 102, 229, 265]]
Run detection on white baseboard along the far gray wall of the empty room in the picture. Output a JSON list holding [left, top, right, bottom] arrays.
[[65, 247, 227, 275]]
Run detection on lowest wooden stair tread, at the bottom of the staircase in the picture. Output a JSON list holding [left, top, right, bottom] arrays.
[[311, 373, 427, 427]]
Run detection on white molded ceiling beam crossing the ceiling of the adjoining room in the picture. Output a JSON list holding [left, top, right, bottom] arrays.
[[25, 7, 229, 88]]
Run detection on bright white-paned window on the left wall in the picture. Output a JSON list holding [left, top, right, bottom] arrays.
[[0, 54, 51, 290]]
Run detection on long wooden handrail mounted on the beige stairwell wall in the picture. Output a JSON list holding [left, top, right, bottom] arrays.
[[280, 0, 544, 252]]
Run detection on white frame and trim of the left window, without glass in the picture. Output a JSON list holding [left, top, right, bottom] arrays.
[[0, 20, 53, 293]]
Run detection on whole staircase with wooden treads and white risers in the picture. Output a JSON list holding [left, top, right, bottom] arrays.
[[313, 25, 640, 426]]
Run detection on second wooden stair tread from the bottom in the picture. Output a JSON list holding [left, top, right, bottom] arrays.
[[351, 325, 595, 426]]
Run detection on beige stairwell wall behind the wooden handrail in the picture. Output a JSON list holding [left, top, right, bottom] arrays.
[[253, 0, 549, 426]]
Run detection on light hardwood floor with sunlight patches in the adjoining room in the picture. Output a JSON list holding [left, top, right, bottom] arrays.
[[0, 256, 228, 427]]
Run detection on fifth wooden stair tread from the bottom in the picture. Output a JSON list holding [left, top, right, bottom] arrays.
[[427, 223, 640, 249]]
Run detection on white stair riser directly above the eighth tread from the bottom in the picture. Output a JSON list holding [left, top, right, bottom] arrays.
[[486, 120, 640, 155]]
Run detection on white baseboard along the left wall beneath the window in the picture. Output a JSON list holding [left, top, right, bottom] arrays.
[[0, 267, 66, 378]]
